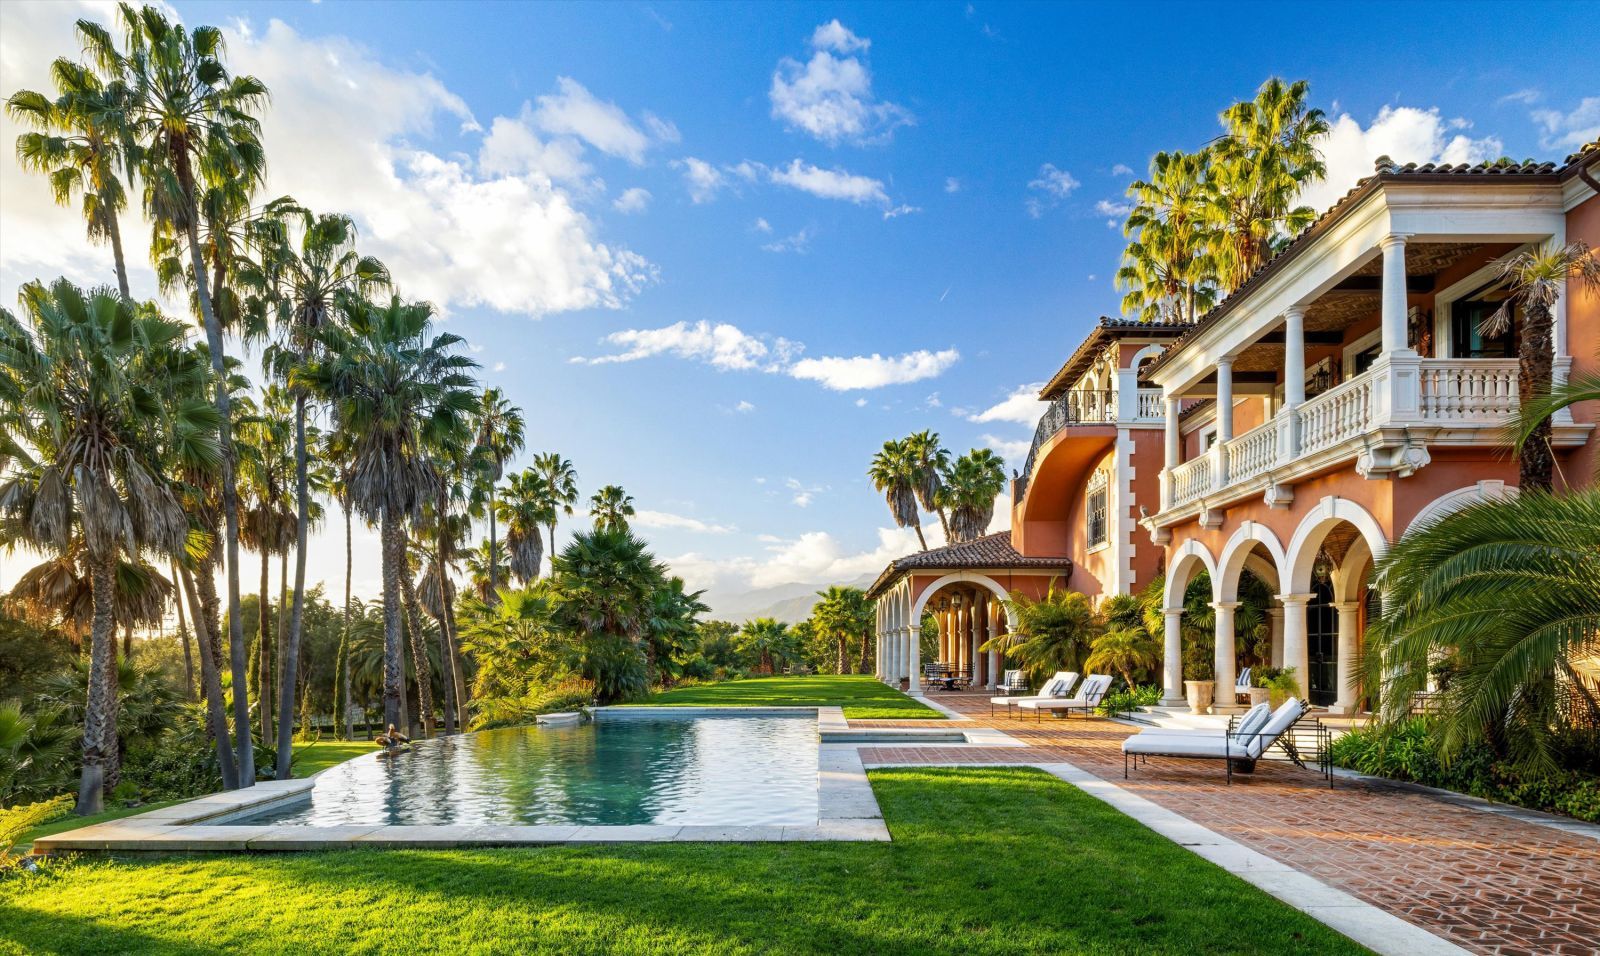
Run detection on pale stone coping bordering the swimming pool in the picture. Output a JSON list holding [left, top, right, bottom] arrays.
[[34, 707, 890, 855]]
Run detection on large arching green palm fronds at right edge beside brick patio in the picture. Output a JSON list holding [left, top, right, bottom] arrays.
[[1362, 489, 1600, 769]]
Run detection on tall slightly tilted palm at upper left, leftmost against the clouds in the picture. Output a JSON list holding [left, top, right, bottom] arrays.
[[6, 58, 139, 299]]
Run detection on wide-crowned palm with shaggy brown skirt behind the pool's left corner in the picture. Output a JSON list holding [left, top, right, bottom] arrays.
[[294, 296, 477, 738]]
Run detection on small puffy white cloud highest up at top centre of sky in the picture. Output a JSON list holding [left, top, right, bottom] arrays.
[[768, 19, 915, 145]]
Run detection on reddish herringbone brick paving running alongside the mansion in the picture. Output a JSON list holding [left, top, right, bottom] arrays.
[[850, 694, 1600, 956]]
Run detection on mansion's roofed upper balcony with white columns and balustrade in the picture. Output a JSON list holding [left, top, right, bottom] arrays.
[[1147, 159, 1590, 529]]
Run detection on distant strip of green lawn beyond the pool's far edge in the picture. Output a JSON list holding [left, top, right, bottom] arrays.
[[642, 675, 944, 719]]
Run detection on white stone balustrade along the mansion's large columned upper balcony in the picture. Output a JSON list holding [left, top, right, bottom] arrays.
[[1166, 358, 1518, 508]]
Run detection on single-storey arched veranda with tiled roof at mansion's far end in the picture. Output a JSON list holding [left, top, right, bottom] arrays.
[[867, 531, 1072, 695]]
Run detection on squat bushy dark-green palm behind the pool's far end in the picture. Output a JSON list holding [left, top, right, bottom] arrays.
[[550, 526, 666, 703]]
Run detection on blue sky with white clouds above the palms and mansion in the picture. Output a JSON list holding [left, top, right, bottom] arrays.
[[0, 2, 1600, 610]]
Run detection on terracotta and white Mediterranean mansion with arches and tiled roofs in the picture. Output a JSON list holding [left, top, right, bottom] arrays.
[[869, 144, 1600, 713]]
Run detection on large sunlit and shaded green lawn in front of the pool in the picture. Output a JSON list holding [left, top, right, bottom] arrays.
[[0, 767, 1365, 956]]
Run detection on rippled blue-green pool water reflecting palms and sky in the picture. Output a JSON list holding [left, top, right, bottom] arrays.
[[229, 715, 818, 827]]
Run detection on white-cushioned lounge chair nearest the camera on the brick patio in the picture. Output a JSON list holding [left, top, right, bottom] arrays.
[[1122, 697, 1333, 787]]
